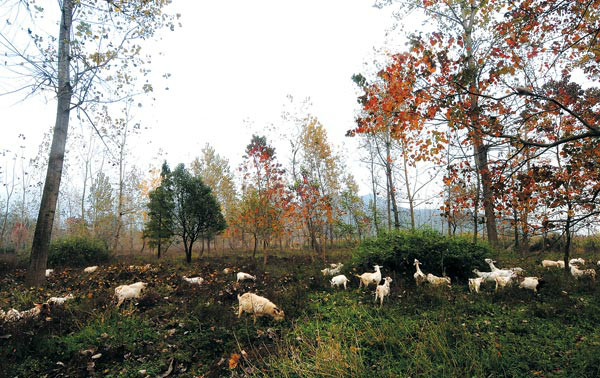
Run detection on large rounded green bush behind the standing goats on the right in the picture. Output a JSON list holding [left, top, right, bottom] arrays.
[[352, 230, 491, 281]]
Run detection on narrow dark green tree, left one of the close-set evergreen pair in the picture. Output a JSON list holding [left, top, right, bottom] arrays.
[[144, 161, 175, 259]]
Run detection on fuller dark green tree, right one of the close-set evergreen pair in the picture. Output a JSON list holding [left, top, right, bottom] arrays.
[[171, 164, 227, 263]]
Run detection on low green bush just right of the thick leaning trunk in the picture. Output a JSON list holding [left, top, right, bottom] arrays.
[[48, 236, 108, 266]]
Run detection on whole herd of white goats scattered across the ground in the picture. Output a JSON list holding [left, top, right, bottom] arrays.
[[0, 258, 600, 324]]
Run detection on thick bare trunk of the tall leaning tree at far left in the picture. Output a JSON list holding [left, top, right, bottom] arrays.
[[26, 0, 74, 286]]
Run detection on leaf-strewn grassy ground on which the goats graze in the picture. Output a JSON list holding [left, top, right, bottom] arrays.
[[0, 251, 600, 377]]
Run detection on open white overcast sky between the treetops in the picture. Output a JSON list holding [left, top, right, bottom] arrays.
[[0, 0, 410, 193]]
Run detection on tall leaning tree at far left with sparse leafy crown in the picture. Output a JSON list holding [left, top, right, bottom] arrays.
[[0, 0, 174, 285]]
